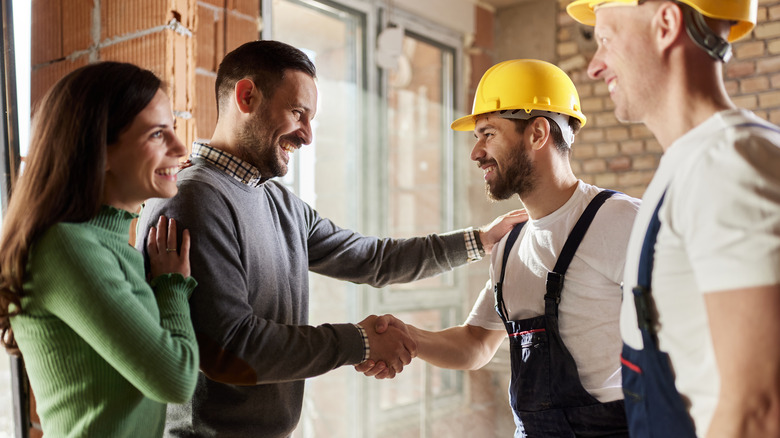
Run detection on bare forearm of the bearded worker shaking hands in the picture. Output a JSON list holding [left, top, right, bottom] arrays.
[[409, 325, 505, 370]]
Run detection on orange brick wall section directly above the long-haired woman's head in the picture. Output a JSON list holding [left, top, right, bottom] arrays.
[[30, 0, 196, 149]]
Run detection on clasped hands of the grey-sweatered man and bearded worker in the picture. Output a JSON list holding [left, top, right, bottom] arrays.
[[355, 315, 417, 379]]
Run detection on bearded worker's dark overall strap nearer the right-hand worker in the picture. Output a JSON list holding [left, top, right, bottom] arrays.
[[544, 190, 617, 316]]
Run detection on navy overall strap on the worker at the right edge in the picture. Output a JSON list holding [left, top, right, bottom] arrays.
[[631, 190, 666, 340]]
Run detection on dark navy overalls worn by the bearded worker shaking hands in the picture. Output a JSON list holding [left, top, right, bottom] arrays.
[[494, 190, 628, 438]]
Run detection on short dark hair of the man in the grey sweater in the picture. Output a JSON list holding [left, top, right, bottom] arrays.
[[215, 40, 317, 116]]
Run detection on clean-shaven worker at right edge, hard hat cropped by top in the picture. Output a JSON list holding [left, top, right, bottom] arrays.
[[567, 0, 780, 438]]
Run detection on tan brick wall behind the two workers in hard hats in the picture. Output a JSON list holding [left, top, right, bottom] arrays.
[[557, 0, 780, 196]]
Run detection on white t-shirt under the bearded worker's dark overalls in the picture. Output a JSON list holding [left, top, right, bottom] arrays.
[[466, 181, 640, 402]]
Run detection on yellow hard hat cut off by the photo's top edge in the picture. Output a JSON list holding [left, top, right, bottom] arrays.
[[566, 0, 758, 42]]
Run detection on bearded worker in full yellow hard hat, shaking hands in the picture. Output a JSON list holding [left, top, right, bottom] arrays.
[[360, 59, 639, 437]]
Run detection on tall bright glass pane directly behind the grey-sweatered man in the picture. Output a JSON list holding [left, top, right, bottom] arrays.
[[271, 0, 365, 438]]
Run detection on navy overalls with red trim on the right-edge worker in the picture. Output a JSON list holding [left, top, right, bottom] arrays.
[[620, 192, 696, 438]]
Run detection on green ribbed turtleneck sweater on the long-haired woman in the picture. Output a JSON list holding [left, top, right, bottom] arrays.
[[11, 206, 198, 437]]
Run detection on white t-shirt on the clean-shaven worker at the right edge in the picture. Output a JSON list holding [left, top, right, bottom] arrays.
[[620, 110, 780, 436]]
